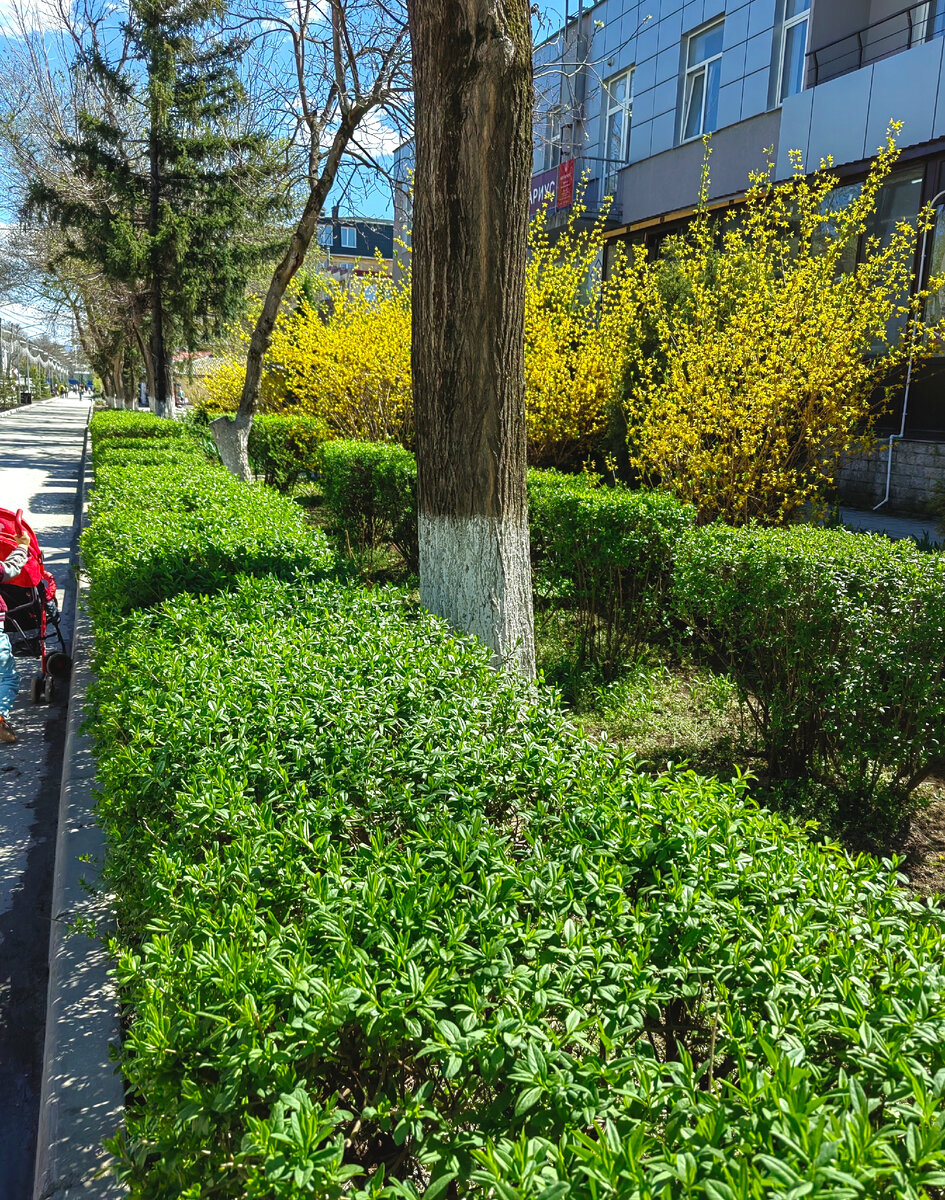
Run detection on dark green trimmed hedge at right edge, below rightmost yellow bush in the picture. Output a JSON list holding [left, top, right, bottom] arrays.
[[673, 526, 945, 822]]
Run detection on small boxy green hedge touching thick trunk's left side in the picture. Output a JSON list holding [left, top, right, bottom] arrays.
[[320, 440, 419, 570]]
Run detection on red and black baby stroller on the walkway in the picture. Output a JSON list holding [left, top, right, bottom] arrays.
[[0, 509, 72, 704]]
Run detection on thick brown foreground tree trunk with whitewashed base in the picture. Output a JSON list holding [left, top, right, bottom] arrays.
[[409, 0, 535, 678]]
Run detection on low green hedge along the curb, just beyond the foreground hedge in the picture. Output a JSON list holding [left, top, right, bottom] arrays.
[[82, 413, 332, 618]]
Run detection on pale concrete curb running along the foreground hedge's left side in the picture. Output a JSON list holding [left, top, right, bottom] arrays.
[[32, 408, 127, 1200]]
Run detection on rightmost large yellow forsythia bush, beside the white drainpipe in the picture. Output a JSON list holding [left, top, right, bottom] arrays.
[[627, 134, 937, 523]]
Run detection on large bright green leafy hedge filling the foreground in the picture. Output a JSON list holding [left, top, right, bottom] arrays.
[[85, 420, 945, 1200]]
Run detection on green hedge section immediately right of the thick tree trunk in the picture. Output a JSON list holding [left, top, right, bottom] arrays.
[[529, 470, 696, 664]]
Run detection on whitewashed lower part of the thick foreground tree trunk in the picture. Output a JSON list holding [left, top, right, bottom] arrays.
[[419, 512, 535, 679]]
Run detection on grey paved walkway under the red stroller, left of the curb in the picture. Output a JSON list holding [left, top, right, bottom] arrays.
[[0, 400, 89, 1200]]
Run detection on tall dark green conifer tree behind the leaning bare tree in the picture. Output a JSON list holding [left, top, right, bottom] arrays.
[[31, 0, 277, 415]]
